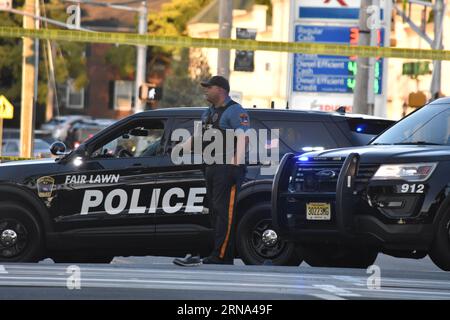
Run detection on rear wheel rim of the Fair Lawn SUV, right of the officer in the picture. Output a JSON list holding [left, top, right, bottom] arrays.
[[249, 219, 286, 259]]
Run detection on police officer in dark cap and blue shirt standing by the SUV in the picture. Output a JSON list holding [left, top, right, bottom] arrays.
[[174, 76, 250, 266]]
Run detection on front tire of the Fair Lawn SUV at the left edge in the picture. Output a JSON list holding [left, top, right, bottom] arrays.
[[0, 201, 44, 262]]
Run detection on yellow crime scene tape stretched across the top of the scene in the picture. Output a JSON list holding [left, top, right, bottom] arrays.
[[0, 27, 450, 60]]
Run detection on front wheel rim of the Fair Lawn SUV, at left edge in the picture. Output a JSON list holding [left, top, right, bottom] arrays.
[[0, 219, 28, 259]]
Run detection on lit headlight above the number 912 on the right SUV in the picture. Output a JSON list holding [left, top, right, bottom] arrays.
[[372, 162, 437, 182]]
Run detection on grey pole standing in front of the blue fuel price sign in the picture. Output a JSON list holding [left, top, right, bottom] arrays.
[[353, 0, 373, 114]]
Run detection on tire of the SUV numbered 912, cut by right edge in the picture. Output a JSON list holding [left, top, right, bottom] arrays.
[[429, 211, 450, 271]]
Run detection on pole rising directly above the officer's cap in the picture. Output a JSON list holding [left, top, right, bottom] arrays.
[[217, 0, 233, 79]]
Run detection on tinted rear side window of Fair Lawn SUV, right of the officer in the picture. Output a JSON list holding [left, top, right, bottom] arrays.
[[263, 121, 338, 152]]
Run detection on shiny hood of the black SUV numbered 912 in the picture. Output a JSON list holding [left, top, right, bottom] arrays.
[[302, 145, 450, 163]]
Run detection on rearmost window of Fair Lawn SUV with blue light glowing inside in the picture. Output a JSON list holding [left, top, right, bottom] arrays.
[[347, 118, 395, 145]]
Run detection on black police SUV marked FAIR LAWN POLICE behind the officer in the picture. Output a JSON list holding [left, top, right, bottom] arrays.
[[0, 108, 392, 265]]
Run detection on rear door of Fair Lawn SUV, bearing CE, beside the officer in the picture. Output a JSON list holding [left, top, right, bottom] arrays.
[[155, 117, 212, 252]]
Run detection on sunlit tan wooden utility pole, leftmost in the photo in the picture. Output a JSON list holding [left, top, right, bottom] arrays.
[[20, 0, 39, 158]]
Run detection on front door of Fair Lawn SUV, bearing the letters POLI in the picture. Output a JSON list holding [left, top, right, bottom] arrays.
[[52, 118, 167, 247]]
